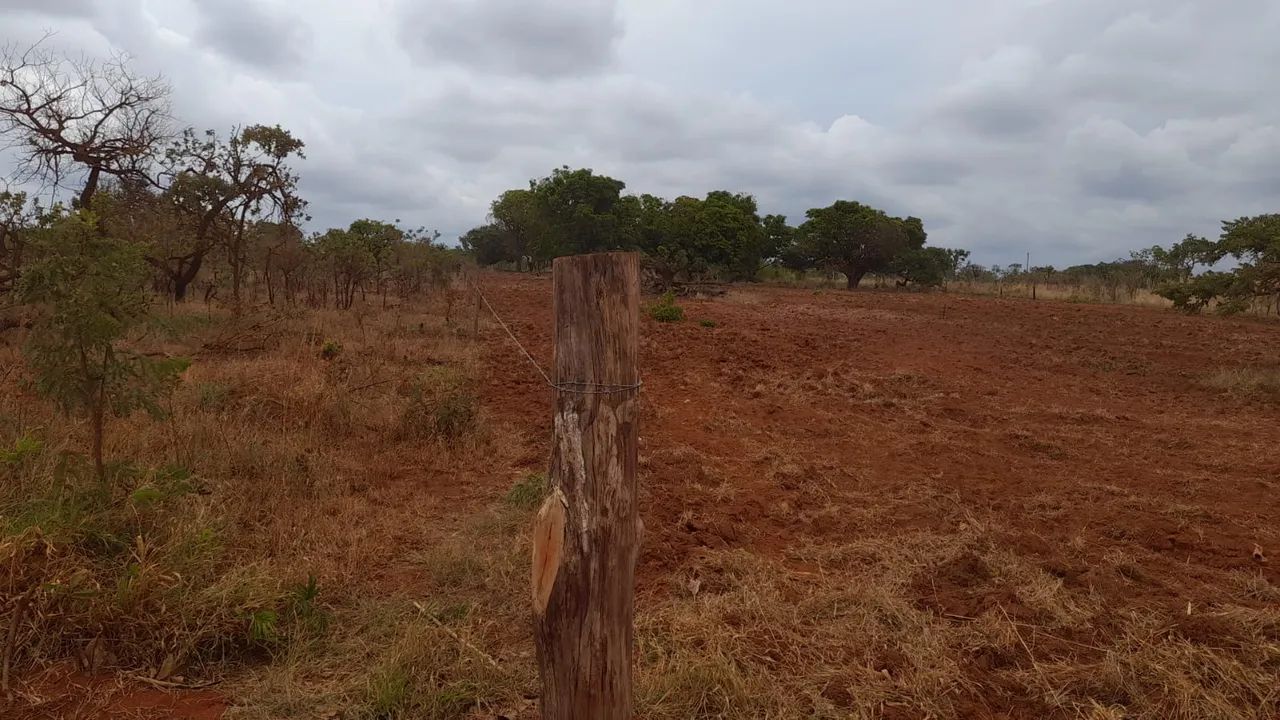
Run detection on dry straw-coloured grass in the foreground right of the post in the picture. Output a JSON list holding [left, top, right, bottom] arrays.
[[637, 525, 1280, 720]]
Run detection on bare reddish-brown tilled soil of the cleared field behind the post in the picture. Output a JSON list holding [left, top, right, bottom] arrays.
[[485, 274, 1280, 655]]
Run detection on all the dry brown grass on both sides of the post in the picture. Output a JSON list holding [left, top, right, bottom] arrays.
[[0, 278, 1280, 720]]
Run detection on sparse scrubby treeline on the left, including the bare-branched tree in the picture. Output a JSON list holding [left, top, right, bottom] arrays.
[[0, 44, 462, 308]]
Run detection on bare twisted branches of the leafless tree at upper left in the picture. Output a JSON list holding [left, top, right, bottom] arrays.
[[0, 36, 172, 208]]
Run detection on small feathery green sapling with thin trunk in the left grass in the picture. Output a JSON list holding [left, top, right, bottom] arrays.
[[18, 211, 187, 483]]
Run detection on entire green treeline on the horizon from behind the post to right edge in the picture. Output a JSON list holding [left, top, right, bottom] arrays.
[[461, 167, 1280, 313]]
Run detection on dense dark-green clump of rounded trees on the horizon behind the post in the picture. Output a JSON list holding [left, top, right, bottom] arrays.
[[461, 168, 969, 288]]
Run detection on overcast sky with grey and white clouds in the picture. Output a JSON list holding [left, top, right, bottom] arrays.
[[0, 0, 1280, 265]]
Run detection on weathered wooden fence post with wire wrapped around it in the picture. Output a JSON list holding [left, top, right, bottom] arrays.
[[532, 252, 641, 720]]
